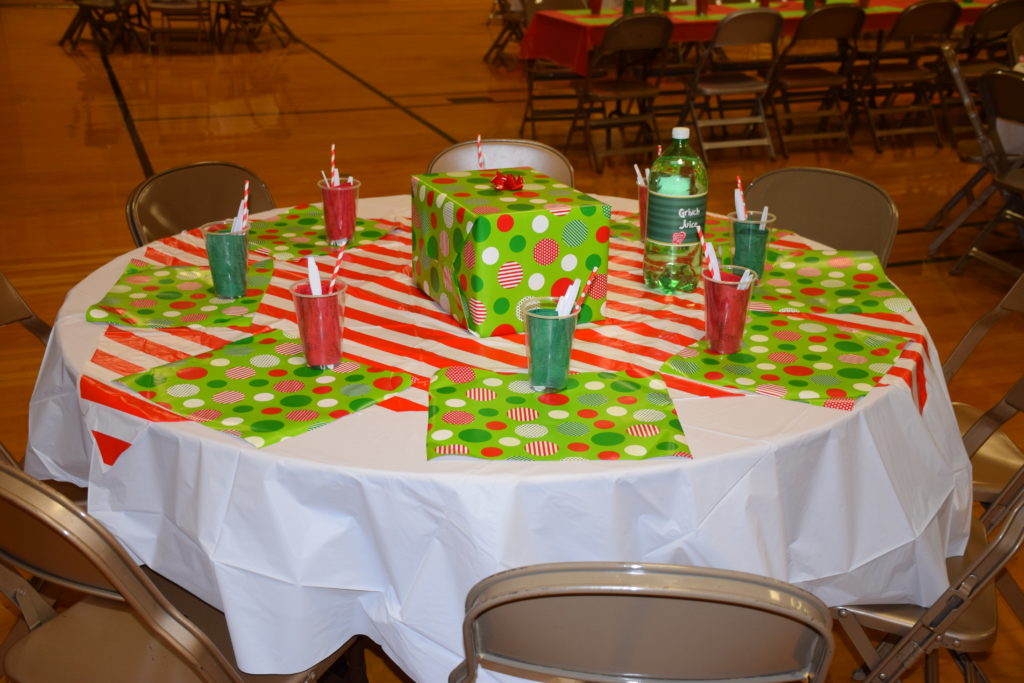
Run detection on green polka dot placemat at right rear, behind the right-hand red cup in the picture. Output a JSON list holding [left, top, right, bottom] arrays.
[[751, 249, 913, 319]]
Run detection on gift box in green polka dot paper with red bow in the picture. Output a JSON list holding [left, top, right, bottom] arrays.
[[412, 169, 611, 337]]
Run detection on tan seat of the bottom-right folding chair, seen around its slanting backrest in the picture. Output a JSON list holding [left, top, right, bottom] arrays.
[[843, 519, 996, 652]]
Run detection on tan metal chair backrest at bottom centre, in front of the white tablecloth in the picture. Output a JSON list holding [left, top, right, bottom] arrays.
[[450, 562, 833, 682]]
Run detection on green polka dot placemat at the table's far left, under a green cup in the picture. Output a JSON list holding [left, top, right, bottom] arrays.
[[86, 260, 273, 328]]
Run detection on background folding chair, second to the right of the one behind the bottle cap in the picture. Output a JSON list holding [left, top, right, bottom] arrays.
[[854, 0, 961, 152]]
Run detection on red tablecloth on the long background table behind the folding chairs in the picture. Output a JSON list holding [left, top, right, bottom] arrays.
[[519, 0, 993, 74]]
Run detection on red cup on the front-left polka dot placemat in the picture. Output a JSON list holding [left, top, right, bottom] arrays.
[[292, 280, 346, 368]]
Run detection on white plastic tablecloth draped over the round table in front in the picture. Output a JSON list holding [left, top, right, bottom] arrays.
[[27, 197, 971, 682]]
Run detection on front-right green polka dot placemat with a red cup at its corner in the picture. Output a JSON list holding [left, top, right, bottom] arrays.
[[662, 311, 908, 411]]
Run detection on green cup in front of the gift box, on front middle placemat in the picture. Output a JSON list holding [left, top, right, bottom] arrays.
[[524, 297, 580, 392]]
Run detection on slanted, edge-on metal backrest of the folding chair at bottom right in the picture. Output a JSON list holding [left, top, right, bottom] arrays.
[[864, 479, 1024, 683]]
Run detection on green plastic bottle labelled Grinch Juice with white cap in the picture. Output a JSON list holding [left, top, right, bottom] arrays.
[[643, 126, 708, 294]]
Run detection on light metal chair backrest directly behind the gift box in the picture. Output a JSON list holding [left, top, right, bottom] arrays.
[[427, 139, 575, 187]]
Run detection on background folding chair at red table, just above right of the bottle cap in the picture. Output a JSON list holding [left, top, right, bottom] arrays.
[[686, 8, 782, 160]]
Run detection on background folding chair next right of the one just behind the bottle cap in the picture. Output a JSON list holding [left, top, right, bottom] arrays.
[[768, 4, 864, 156]]
